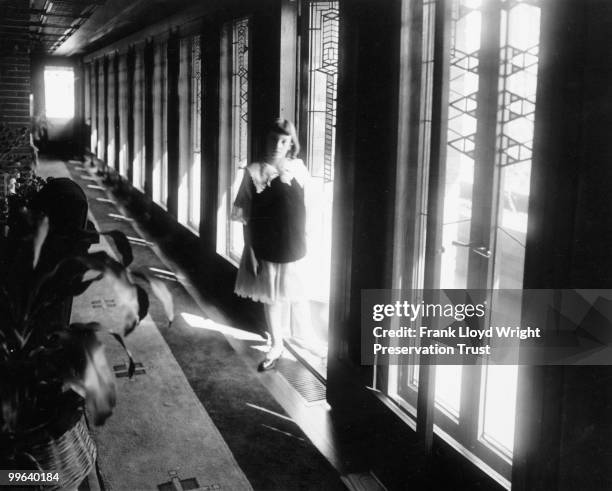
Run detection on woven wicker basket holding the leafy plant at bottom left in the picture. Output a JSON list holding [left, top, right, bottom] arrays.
[[29, 416, 96, 489]]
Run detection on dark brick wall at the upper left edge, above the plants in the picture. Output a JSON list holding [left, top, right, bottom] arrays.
[[0, 0, 32, 165]]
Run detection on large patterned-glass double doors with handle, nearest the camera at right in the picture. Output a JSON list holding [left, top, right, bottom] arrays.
[[388, 0, 540, 479]]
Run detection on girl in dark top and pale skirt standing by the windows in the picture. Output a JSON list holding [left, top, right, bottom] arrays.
[[232, 119, 308, 371]]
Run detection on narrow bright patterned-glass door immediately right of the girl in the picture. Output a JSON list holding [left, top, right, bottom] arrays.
[[290, 1, 340, 377]]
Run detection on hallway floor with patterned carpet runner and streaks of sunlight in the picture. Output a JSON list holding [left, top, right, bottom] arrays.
[[38, 158, 345, 490]]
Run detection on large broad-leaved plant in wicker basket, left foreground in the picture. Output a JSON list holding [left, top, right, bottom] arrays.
[[0, 181, 172, 489]]
